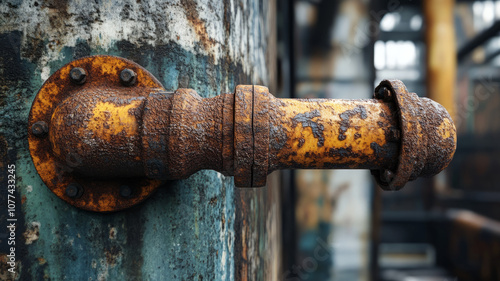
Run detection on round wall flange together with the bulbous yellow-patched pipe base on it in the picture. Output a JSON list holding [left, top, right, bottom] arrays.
[[28, 56, 164, 212]]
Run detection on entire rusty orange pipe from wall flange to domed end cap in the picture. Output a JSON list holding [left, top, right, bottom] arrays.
[[29, 56, 456, 210]]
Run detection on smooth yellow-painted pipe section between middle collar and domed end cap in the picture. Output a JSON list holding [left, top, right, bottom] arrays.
[[271, 99, 398, 169]]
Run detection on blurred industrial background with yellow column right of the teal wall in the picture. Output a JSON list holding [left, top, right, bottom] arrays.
[[278, 0, 500, 281]]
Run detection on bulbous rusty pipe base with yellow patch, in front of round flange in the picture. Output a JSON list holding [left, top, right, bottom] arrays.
[[48, 90, 144, 176]]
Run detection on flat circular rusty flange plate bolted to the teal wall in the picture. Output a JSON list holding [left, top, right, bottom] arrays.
[[28, 56, 164, 212]]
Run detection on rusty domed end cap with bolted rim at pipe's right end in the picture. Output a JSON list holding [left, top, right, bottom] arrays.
[[372, 80, 457, 190]]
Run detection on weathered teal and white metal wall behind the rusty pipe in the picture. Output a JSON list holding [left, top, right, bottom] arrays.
[[0, 0, 281, 280]]
